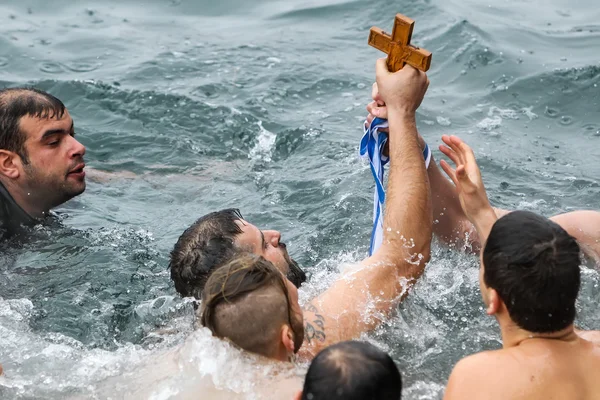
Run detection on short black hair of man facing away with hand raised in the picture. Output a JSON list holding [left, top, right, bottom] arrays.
[[483, 211, 581, 333]]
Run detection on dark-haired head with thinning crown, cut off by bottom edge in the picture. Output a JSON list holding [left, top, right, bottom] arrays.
[[302, 341, 402, 400]]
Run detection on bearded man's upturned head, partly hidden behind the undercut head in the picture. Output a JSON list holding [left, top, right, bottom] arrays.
[[169, 209, 306, 299]]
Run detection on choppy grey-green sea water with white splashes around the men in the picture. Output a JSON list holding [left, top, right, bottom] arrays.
[[0, 0, 600, 399]]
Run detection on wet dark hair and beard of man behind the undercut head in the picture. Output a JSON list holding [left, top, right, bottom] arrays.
[[169, 208, 306, 300]]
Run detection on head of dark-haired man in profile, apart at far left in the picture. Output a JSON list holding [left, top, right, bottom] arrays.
[[0, 88, 85, 212]]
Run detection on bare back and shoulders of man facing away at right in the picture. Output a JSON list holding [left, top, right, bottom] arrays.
[[444, 332, 600, 400]]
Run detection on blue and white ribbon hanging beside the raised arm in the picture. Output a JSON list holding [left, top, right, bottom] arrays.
[[359, 118, 431, 255]]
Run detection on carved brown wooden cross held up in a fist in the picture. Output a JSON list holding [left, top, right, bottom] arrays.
[[369, 14, 431, 72]]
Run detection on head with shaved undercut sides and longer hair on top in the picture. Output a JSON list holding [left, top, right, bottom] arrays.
[[200, 253, 304, 361]]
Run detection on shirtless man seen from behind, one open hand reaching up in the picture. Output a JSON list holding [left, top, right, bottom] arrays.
[[442, 136, 600, 400]]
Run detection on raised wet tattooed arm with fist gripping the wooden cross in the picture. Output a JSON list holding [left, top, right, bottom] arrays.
[[301, 59, 432, 356]]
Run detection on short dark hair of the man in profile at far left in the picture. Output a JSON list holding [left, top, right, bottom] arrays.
[[0, 88, 65, 164]]
